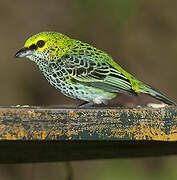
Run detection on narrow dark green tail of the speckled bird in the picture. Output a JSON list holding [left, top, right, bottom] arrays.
[[140, 85, 176, 106]]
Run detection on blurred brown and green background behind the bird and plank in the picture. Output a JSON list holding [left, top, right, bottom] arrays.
[[0, 0, 177, 180]]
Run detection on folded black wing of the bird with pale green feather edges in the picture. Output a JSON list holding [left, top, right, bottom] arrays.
[[62, 54, 136, 94]]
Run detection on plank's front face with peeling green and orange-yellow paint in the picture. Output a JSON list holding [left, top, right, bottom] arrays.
[[0, 107, 177, 141]]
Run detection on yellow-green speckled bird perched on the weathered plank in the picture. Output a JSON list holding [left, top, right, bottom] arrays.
[[15, 32, 176, 107]]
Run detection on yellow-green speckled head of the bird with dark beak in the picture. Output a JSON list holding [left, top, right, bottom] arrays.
[[15, 32, 72, 62]]
